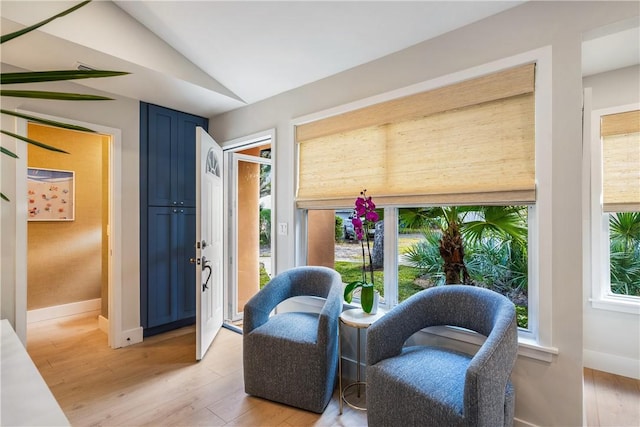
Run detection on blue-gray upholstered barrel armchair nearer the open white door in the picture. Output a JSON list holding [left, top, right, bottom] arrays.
[[243, 266, 342, 413]]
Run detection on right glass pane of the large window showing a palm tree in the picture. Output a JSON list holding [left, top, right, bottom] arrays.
[[398, 206, 528, 328]]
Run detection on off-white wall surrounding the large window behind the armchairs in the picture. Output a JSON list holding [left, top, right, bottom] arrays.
[[210, 2, 638, 426]]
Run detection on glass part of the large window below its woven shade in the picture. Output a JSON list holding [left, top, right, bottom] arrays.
[[308, 206, 529, 329]]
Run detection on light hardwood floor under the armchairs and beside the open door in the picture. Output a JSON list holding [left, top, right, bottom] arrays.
[[27, 313, 640, 427]]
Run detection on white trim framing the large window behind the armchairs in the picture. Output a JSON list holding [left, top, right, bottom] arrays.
[[290, 46, 558, 362]]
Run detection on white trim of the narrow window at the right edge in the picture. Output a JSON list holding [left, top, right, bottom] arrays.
[[585, 103, 640, 314]]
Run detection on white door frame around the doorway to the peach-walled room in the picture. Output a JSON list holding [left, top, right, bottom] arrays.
[[15, 110, 122, 348]]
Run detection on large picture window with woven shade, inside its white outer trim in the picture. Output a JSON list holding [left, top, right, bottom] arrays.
[[296, 63, 536, 330]]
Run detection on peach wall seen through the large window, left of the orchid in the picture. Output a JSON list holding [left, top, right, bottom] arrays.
[[307, 210, 336, 268]]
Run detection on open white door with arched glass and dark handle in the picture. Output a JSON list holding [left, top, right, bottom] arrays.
[[195, 127, 224, 360]]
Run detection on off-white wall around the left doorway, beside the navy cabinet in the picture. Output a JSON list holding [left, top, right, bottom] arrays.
[[0, 64, 140, 336]]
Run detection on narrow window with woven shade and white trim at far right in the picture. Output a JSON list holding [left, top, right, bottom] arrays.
[[590, 106, 640, 313]]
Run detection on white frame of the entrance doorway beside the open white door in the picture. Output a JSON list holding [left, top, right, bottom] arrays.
[[221, 128, 278, 322]]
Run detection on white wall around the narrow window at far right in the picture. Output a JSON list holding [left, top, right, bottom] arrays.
[[583, 66, 640, 378]]
